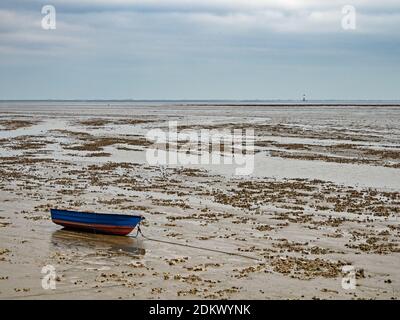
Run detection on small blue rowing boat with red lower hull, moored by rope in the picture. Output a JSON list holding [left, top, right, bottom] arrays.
[[50, 209, 144, 236]]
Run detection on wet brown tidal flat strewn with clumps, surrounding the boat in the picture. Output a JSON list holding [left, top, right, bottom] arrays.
[[0, 102, 400, 299]]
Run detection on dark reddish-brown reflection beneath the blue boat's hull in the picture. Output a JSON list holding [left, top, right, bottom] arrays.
[[51, 229, 146, 255]]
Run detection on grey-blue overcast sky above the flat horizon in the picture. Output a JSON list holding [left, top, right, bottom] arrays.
[[0, 0, 400, 99]]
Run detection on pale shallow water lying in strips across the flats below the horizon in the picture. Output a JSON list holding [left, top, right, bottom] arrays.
[[0, 102, 400, 189]]
